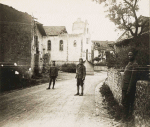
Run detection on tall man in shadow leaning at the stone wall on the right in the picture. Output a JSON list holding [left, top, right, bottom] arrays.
[[122, 50, 138, 121]]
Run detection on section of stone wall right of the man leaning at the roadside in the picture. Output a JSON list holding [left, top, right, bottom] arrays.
[[134, 81, 150, 127]]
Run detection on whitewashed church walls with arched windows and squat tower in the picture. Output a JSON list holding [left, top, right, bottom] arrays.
[[41, 19, 92, 64]]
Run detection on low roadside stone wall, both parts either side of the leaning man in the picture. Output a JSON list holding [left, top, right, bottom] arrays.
[[106, 68, 150, 127]]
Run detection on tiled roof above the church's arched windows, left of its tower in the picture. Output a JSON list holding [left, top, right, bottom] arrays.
[[44, 26, 67, 36]]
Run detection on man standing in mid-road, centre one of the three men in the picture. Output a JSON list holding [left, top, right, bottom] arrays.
[[75, 58, 86, 96]]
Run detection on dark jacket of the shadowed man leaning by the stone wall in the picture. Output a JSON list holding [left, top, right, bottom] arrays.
[[122, 61, 138, 92]]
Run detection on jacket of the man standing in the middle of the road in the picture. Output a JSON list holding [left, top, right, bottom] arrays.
[[76, 64, 86, 79]]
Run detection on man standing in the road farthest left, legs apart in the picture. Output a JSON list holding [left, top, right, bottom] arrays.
[[47, 61, 58, 89]]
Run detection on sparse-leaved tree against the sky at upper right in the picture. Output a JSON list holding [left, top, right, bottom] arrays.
[[92, 0, 149, 38]]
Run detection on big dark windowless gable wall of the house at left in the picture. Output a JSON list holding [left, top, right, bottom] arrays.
[[0, 4, 32, 70]]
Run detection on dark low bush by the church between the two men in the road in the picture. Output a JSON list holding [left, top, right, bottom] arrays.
[[61, 63, 76, 73]]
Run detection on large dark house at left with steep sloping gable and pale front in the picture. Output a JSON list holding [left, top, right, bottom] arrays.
[[0, 4, 46, 75]]
